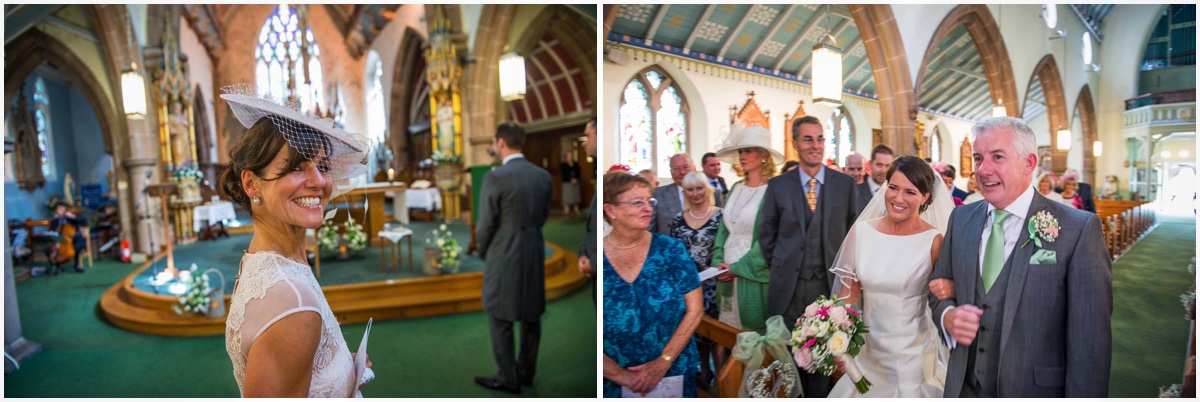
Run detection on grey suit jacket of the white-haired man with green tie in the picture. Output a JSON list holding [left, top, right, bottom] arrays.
[[929, 192, 1112, 397]]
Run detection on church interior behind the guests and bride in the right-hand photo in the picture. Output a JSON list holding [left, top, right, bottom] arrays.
[[599, 4, 1198, 397]]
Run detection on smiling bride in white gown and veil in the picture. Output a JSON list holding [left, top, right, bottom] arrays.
[[829, 156, 954, 397]]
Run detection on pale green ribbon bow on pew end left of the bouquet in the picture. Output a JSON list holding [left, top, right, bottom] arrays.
[[733, 316, 800, 397]]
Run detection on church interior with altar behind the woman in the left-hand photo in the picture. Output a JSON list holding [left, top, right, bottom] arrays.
[[4, 4, 599, 397]]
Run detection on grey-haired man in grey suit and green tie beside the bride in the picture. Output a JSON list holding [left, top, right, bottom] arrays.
[[929, 116, 1112, 397]]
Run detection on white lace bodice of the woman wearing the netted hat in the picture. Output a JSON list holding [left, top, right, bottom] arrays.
[[226, 252, 356, 397]]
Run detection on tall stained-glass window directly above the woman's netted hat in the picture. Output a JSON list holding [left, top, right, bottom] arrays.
[[254, 5, 324, 112]]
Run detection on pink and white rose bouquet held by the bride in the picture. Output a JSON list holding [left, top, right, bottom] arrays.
[[788, 295, 871, 394]]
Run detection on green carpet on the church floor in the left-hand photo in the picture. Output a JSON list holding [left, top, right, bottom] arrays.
[[4, 218, 599, 397]]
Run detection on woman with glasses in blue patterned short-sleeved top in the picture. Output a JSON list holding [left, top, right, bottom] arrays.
[[601, 173, 703, 397]]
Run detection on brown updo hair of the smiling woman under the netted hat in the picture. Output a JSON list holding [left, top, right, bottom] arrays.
[[217, 118, 308, 217]]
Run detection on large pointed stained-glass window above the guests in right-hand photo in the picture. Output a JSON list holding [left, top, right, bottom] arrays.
[[617, 68, 690, 178]]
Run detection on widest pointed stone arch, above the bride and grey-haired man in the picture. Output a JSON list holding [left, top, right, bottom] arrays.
[[912, 5, 1021, 118]]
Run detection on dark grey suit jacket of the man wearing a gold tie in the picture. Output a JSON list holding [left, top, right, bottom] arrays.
[[758, 169, 858, 319]]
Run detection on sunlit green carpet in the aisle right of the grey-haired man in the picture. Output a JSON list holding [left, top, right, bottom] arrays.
[[1109, 217, 1196, 397]]
